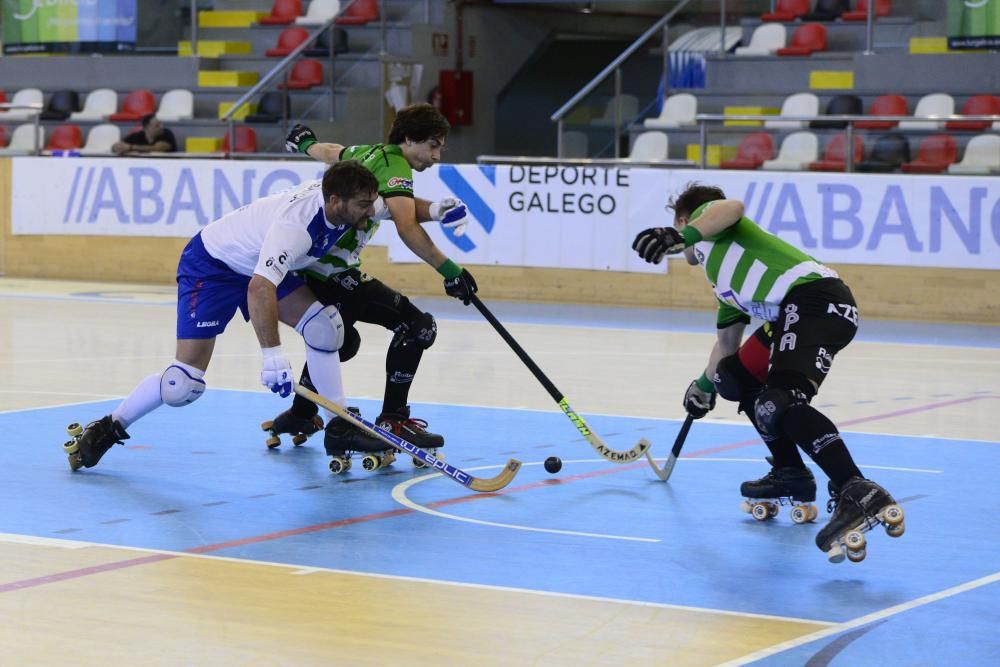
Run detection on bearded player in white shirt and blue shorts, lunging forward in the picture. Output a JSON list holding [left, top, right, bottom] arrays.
[[65, 161, 378, 470]]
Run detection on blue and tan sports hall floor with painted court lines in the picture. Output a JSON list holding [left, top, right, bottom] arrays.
[[0, 278, 1000, 667]]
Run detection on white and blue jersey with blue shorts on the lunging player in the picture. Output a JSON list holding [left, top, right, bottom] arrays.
[[177, 180, 351, 338]]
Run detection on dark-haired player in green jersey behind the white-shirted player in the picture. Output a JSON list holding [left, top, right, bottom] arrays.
[[260, 104, 477, 460]]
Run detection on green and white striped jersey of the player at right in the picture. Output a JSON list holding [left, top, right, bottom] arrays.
[[689, 202, 838, 327]]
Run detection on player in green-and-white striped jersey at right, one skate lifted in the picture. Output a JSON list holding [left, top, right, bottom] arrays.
[[632, 184, 902, 560]]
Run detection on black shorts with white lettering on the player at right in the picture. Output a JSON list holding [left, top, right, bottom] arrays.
[[768, 278, 858, 389]]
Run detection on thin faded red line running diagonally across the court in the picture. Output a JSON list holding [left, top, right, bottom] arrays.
[[0, 395, 1000, 593]]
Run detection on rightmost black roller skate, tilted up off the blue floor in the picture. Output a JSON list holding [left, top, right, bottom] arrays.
[[816, 477, 906, 563]]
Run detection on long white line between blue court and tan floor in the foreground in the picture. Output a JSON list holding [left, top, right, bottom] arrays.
[[0, 528, 836, 626]]
